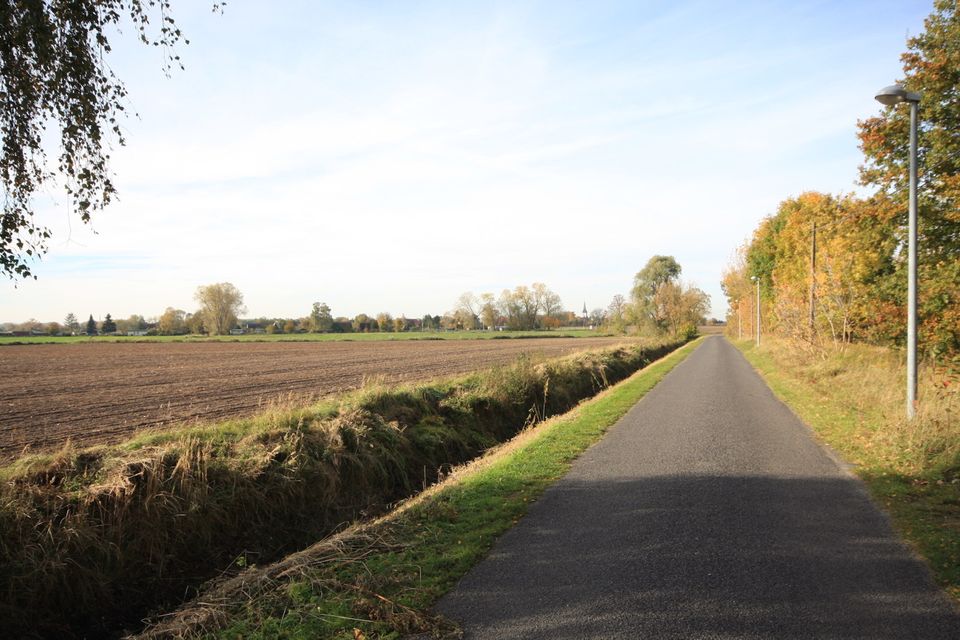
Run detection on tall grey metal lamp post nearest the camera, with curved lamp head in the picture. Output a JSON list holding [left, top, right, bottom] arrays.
[[875, 84, 920, 420]]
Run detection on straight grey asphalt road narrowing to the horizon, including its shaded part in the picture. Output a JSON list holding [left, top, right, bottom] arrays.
[[437, 337, 960, 640]]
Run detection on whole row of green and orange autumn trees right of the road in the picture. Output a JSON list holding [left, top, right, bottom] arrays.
[[722, 0, 960, 365]]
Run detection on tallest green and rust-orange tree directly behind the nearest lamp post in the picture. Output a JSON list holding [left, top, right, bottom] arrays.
[[857, 0, 960, 355]]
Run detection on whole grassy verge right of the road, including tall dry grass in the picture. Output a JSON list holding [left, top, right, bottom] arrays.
[[737, 339, 960, 602]]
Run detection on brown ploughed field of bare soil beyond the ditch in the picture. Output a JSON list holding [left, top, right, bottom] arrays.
[[0, 338, 623, 459]]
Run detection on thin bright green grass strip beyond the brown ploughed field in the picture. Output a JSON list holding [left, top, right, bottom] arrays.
[[0, 329, 612, 346]]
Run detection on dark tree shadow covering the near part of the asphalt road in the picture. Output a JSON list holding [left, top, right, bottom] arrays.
[[438, 475, 960, 640]]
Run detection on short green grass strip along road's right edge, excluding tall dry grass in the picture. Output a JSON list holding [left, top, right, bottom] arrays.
[[734, 341, 960, 603]]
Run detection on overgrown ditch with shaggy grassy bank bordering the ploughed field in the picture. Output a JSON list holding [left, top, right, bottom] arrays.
[[0, 341, 679, 637]]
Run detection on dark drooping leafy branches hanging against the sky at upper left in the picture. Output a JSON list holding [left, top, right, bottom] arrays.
[[0, 0, 219, 278]]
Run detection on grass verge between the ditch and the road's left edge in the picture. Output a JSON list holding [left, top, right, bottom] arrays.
[[139, 339, 702, 640]]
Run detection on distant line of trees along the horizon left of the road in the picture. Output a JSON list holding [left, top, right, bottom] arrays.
[[3, 256, 710, 335]]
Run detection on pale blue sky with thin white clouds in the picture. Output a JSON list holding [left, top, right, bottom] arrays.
[[0, 0, 932, 322]]
